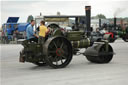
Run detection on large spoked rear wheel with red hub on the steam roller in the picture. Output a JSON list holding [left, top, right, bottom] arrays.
[[44, 37, 72, 68]]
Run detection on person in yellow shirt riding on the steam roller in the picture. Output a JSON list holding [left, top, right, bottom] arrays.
[[39, 21, 48, 44]]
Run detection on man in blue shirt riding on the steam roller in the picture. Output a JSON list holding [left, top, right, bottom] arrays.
[[26, 20, 38, 42]]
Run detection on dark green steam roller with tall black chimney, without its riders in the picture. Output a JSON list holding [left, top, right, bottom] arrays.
[[19, 6, 114, 68]]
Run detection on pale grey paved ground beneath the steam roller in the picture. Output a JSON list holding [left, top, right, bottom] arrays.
[[0, 40, 128, 85]]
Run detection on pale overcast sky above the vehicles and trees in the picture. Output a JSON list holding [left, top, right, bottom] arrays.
[[0, 0, 128, 23]]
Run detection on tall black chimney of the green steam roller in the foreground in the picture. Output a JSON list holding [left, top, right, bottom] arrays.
[[85, 6, 91, 36]]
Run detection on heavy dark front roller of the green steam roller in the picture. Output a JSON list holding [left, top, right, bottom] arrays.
[[84, 42, 114, 63]]
